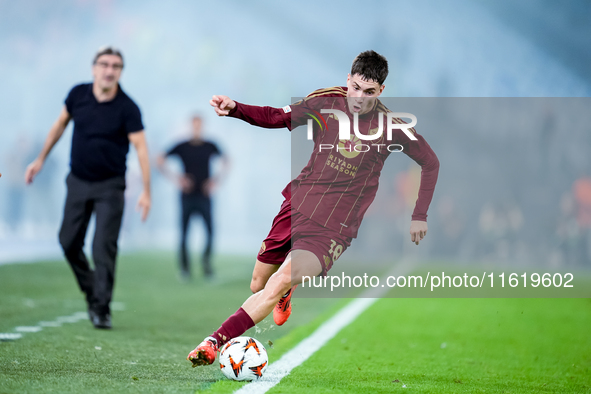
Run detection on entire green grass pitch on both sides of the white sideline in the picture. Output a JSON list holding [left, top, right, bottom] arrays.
[[0, 253, 591, 393]]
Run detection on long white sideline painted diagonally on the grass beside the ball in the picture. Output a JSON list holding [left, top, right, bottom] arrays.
[[234, 261, 412, 394]]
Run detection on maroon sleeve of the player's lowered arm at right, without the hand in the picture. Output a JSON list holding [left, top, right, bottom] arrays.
[[393, 131, 439, 221]]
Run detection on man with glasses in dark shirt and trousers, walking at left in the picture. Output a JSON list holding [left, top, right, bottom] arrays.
[[25, 47, 150, 329]]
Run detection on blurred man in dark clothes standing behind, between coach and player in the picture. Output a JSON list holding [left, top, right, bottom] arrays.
[[157, 116, 228, 280]]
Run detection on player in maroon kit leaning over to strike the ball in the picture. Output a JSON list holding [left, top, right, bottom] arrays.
[[187, 51, 439, 366]]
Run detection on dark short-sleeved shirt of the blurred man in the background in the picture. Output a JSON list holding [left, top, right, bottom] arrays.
[[166, 141, 221, 195]]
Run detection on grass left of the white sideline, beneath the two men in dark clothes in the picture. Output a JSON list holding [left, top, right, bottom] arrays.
[[0, 253, 338, 393]]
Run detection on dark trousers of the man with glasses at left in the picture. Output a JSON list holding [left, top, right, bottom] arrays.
[[59, 174, 125, 314]]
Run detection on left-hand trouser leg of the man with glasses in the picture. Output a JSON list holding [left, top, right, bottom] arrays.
[[59, 174, 95, 310]]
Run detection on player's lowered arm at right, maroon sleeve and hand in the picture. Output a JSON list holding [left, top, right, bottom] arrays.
[[401, 133, 439, 245]]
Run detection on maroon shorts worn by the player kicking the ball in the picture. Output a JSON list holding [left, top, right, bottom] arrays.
[[257, 199, 352, 276]]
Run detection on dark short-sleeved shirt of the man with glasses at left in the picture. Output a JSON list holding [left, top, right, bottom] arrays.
[[66, 83, 144, 182]]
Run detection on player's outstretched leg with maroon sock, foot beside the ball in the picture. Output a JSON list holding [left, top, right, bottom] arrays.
[[187, 250, 323, 366]]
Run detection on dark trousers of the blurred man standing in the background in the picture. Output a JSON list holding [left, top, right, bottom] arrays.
[[180, 194, 213, 276]]
